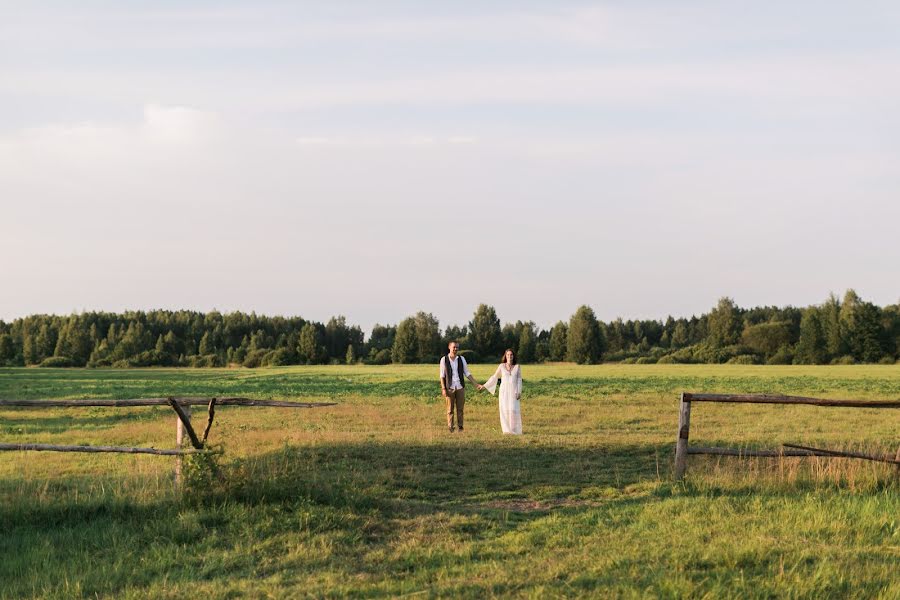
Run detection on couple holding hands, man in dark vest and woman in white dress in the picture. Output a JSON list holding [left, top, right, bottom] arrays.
[[441, 341, 522, 435]]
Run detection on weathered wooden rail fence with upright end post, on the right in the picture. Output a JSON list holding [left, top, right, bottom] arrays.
[[675, 392, 900, 480]]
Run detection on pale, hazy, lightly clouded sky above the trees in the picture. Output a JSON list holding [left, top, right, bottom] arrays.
[[0, 0, 900, 331]]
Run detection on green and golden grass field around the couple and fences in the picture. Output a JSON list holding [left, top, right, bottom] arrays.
[[0, 365, 900, 598]]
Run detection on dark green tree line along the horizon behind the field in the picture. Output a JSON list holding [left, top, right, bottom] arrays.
[[0, 290, 900, 368]]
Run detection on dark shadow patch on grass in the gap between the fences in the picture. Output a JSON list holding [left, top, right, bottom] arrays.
[[209, 442, 671, 510]]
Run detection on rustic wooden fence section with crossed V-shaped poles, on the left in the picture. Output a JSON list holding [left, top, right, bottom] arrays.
[[0, 396, 336, 490]]
